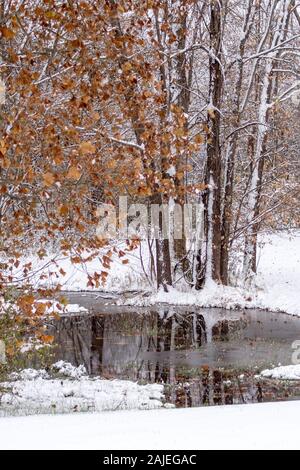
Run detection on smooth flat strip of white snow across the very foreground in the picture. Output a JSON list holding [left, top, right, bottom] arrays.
[[0, 402, 300, 450]]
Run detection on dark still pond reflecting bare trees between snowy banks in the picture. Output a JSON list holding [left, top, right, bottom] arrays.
[[37, 293, 300, 407]]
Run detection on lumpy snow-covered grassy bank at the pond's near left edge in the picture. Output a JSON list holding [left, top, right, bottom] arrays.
[[0, 361, 164, 415]]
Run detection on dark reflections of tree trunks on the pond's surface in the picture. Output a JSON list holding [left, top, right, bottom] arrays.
[[47, 309, 300, 407]]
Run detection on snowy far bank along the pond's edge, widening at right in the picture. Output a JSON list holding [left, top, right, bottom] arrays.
[[119, 232, 300, 316]]
